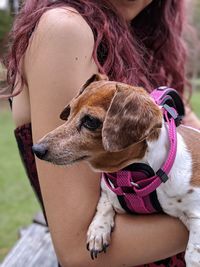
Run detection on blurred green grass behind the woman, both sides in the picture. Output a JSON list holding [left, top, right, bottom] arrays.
[[0, 91, 200, 261]]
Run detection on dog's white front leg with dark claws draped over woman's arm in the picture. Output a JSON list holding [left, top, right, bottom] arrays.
[[87, 182, 115, 259]]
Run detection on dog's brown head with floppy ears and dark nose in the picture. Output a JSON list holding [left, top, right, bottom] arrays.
[[33, 74, 162, 171]]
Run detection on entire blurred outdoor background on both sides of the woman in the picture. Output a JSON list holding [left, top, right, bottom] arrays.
[[0, 0, 200, 262]]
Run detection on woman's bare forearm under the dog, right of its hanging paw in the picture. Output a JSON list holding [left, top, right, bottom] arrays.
[[108, 214, 188, 266]]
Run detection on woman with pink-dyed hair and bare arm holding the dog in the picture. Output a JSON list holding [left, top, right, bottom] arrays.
[[3, 0, 200, 267]]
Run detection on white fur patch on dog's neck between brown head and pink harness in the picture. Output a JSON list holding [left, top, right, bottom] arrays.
[[142, 121, 169, 172]]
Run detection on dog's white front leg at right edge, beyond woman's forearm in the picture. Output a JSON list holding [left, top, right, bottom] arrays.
[[185, 219, 200, 267]]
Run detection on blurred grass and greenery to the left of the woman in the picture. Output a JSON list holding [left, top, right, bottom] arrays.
[[0, 0, 40, 262]]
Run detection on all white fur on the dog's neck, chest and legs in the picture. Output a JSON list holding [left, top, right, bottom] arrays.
[[87, 123, 200, 267]]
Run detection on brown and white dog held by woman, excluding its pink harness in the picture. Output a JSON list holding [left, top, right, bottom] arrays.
[[33, 75, 200, 267]]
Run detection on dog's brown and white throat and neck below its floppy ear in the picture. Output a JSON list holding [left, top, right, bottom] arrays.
[[90, 121, 172, 172]]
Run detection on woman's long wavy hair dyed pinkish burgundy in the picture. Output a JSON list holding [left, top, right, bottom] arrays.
[[3, 0, 186, 95]]
